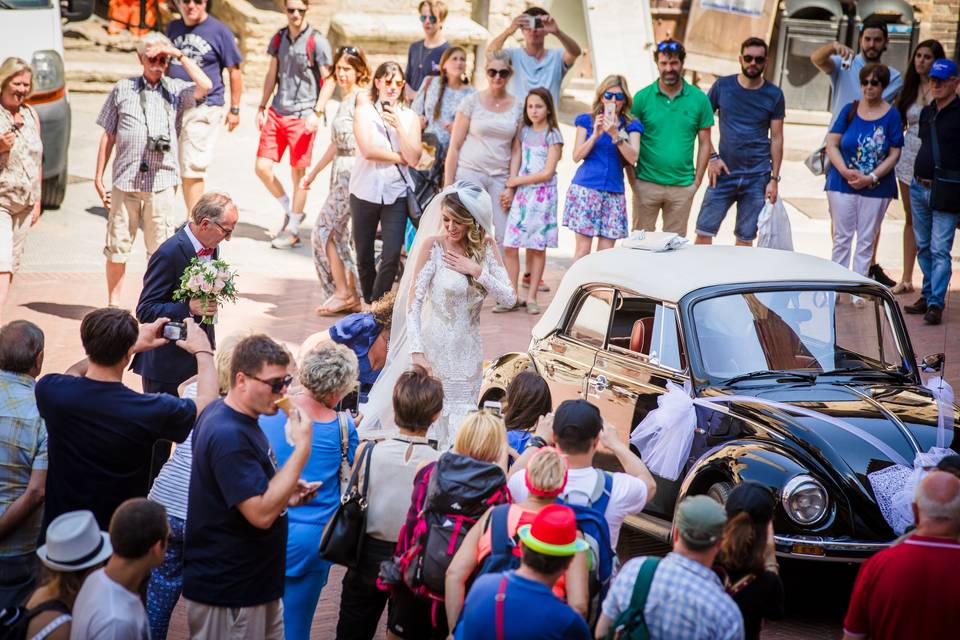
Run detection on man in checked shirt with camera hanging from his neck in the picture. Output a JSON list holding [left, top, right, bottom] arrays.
[[93, 33, 213, 307]]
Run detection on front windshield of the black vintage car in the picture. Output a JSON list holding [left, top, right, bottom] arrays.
[[693, 290, 910, 384]]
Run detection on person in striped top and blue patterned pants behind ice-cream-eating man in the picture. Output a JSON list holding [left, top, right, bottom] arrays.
[[147, 332, 250, 640]]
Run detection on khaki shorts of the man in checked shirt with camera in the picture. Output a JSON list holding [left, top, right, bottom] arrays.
[[103, 187, 177, 262]]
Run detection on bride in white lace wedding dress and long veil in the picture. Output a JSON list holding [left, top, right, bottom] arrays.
[[362, 181, 516, 451]]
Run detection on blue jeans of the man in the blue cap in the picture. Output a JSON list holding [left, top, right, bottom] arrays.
[[910, 180, 957, 309]]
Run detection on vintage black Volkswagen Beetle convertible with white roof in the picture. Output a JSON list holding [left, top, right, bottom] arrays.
[[480, 246, 960, 561]]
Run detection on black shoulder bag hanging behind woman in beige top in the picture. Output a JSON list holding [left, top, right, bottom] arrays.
[[317, 442, 376, 568]]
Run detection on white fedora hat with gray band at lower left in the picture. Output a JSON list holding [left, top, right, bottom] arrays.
[[37, 511, 113, 571]]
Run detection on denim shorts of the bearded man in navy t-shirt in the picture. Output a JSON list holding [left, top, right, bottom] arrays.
[[697, 173, 770, 241]]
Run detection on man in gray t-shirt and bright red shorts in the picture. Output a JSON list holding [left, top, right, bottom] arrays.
[[256, 0, 335, 249]]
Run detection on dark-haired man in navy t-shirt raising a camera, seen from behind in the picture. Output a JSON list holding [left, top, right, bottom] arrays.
[[35, 308, 218, 531]]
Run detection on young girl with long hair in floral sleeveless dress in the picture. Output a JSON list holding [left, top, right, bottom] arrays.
[[502, 87, 563, 315]]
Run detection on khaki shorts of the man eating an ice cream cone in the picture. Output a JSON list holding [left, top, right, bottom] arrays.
[[183, 598, 283, 640]]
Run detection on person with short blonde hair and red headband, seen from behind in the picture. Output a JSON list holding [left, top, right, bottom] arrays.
[[444, 447, 589, 620]]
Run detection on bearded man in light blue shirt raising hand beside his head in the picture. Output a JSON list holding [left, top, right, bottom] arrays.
[[810, 20, 903, 287]]
